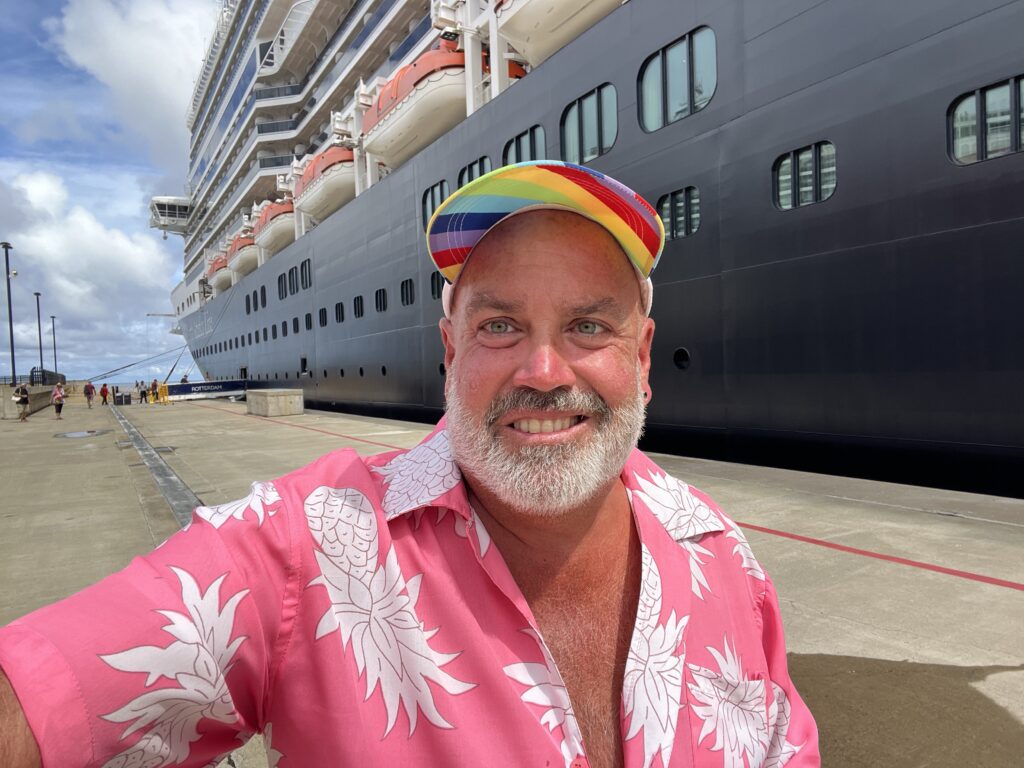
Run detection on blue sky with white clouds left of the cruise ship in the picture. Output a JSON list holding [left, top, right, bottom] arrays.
[[0, 0, 220, 380]]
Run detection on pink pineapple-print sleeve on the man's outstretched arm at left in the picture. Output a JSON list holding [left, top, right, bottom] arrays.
[[0, 483, 298, 768]]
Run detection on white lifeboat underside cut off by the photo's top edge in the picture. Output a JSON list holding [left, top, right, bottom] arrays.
[[495, 0, 623, 67]]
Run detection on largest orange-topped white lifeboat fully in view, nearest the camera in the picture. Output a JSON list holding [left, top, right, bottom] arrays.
[[362, 41, 525, 168]]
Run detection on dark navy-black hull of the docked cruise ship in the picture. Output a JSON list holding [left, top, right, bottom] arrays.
[[181, 0, 1024, 489]]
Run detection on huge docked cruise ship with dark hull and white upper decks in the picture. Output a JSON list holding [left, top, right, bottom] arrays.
[[152, 0, 1024, 475]]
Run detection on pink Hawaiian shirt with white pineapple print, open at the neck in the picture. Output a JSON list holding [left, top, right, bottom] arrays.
[[0, 427, 819, 768]]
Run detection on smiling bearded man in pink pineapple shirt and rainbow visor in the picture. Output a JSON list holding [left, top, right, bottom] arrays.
[[0, 163, 819, 768]]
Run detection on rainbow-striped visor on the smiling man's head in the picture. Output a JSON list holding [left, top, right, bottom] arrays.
[[427, 160, 665, 284]]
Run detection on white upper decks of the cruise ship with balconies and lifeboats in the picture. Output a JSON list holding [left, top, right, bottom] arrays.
[[151, 0, 623, 316]]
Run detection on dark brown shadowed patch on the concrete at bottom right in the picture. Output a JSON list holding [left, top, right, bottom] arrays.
[[788, 653, 1024, 768]]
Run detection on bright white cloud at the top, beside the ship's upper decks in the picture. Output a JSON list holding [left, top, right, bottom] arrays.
[[46, 0, 219, 178]]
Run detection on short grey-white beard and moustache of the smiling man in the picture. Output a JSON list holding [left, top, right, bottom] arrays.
[[445, 365, 646, 517]]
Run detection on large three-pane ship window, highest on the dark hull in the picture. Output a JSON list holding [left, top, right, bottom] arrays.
[[637, 27, 718, 132]]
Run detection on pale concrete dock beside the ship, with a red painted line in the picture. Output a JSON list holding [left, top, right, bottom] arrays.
[[0, 398, 1024, 768]]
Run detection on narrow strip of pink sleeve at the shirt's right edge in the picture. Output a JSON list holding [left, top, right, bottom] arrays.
[[762, 577, 821, 768]]
